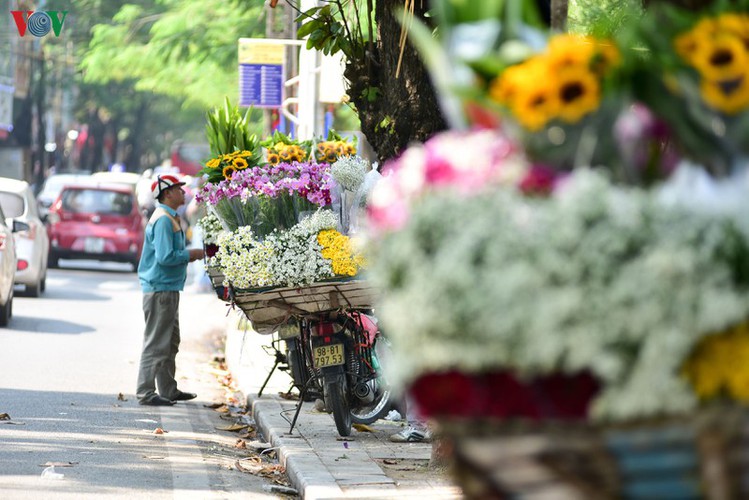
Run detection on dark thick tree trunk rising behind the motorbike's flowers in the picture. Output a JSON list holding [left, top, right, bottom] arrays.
[[345, 0, 446, 164]]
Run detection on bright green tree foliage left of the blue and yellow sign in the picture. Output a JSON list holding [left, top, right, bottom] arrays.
[[81, 0, 264, 108]]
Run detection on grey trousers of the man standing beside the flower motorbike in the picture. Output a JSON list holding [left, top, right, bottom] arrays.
[[136, 292, 180, 401]]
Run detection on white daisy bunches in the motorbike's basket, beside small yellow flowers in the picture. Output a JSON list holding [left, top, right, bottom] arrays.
[[211, 210, 338, 289]]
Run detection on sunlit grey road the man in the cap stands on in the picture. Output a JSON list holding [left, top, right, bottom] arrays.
[[0, 261, 288, 499]]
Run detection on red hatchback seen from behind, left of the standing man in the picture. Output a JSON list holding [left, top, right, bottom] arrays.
[[47, 184, 146, 271]]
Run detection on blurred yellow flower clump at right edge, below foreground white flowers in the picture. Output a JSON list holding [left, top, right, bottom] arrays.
[[682, 323, 749, 403]]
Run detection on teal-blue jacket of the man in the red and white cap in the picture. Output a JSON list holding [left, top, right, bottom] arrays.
[[138, 204, 190, 293]]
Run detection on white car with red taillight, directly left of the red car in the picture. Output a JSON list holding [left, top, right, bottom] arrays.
[[0, 178, 49, 297]]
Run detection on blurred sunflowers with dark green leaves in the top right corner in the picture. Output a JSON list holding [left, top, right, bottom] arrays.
[[633, 0, 749, 175]]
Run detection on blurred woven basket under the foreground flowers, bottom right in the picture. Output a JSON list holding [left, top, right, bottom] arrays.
[[436, 409, 749, 500]]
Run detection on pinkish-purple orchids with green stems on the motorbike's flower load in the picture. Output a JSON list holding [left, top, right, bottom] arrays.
[[197, 162, 331, 238]]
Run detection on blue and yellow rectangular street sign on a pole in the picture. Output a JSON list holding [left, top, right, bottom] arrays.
[[239, 38, 286, 108]]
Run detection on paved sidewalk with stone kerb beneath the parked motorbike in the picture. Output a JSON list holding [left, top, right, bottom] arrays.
[[219, 311, 462, 500]]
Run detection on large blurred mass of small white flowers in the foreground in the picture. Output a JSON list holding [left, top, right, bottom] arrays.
[[369, 170, 749, 420]]
